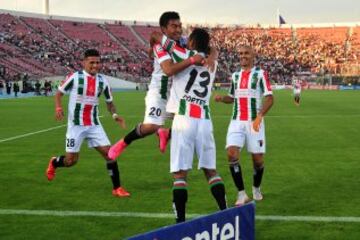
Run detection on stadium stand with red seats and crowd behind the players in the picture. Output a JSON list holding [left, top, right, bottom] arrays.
[[0, 13, 360, 84]]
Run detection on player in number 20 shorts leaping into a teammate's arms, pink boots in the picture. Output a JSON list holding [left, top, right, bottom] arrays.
[[109, 12, 203, 159]]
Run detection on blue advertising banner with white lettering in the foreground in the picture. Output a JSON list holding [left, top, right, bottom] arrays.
[[128, 202, 255, 240]]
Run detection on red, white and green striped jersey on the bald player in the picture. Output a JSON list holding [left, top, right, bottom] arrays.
[[229, 67, 272, 121]]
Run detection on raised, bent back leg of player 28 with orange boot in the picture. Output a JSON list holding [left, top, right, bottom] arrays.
[[46, 153, 79, 181]]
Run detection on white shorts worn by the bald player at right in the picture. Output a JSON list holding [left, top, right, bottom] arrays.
[[226, 120, 265, 153]]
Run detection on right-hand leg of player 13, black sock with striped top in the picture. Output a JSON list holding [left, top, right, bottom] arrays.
[[203, 168, 227, 210]]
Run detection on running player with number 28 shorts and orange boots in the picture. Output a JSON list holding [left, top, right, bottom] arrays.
[[46, 49, 130, 197]]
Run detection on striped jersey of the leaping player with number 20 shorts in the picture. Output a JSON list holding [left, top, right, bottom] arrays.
[[148, 44, 171, 100]]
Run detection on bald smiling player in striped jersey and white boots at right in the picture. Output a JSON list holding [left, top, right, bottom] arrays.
[[214, 46, 273, 206]]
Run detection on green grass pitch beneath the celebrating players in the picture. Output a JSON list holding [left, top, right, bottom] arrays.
[[0, 90, 360, 240]]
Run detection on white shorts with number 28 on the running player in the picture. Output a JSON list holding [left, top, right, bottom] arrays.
[[65, 125, 110, 153]]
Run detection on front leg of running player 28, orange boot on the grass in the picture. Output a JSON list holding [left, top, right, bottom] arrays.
[[95, 146, 130, 197]]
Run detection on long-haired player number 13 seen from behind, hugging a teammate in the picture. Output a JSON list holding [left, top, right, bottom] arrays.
[[162, 28, 227, 223]]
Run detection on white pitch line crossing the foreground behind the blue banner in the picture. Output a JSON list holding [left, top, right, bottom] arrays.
[[0, 209, 360, 223]]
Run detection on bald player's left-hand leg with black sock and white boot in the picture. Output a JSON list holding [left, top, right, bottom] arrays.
[[227, 146, 250, 206]]
